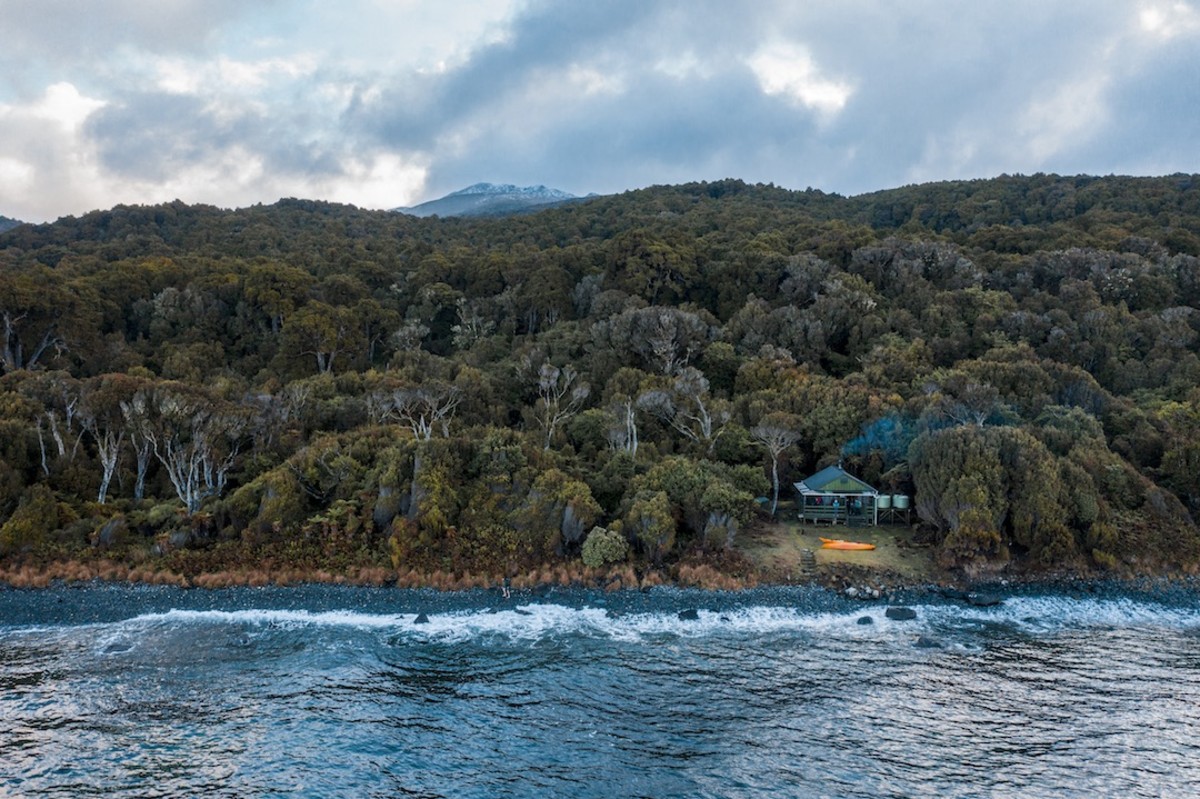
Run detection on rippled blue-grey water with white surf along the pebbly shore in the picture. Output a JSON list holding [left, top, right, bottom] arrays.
[[0, 585, 1200, 799]]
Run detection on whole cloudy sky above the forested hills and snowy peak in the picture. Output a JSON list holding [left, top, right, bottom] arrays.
[[0, 0, 1200, 222]]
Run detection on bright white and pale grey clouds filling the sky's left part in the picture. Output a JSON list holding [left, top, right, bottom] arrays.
[[0, 0, 512, 221]]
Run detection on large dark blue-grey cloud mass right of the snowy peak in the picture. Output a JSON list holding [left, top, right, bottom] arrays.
[[348, 0, 1195, 194]]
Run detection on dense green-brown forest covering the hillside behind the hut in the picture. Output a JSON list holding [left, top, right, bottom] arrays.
[[0, 174, 1200, 578]]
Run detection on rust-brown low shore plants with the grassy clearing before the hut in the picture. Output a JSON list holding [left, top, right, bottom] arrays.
[[7, 513, 1198, 600]]
